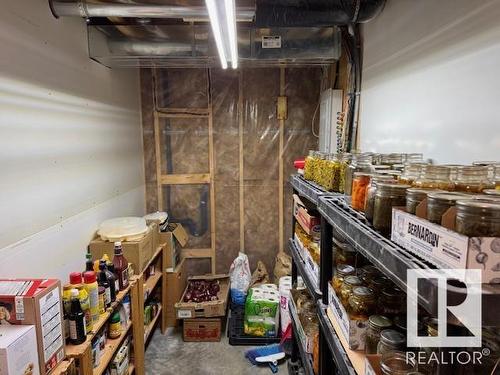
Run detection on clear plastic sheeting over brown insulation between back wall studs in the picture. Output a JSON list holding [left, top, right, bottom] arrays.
[[141, 67, 321, 273]]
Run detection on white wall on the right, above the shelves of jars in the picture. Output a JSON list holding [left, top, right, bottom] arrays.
[[360, 0, 500, 163]]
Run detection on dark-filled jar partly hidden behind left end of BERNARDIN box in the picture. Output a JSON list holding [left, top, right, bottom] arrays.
[[373, 183, 411, 236]]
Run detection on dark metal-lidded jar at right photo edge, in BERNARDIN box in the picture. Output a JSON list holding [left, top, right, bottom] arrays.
[[455, 199, 500, 237]]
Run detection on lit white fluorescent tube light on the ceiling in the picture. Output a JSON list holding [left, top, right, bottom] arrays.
[[205, 0, 238, 69]]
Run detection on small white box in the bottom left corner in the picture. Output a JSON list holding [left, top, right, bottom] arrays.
[[0, 325, 40, 375]]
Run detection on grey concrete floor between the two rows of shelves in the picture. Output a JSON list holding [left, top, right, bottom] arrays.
[[145, 329, 288, 375]]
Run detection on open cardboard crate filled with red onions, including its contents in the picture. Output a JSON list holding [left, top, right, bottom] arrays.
[[175, 275, 229, 319]]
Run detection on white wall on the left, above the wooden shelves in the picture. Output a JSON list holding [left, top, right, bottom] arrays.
[[0, 0, 144, 279]]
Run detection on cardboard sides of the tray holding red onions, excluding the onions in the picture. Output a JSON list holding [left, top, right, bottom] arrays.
[[175, 275, 229, 319]]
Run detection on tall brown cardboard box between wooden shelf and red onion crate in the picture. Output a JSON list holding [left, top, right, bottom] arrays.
[[163, 259, 187, 327]]
